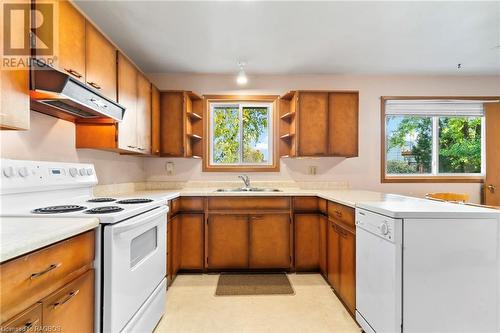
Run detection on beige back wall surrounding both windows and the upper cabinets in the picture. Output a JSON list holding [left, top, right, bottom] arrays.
[[145, 74, 500, 202]]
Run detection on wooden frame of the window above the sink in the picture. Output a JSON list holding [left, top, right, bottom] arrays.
[[203, 95, 280, 172]]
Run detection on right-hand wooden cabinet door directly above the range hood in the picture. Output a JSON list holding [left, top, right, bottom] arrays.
[[85, 21, 116, 101]]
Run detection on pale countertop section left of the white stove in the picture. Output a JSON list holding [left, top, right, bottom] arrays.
[[0, 217, 99, 263]]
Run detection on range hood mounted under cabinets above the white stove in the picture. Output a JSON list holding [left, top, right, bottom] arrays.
[[30, 60, 125, 122]]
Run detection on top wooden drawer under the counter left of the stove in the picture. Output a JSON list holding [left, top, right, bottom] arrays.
[[0, 231, 94, 322]]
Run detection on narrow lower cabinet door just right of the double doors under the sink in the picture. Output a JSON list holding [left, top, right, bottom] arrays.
[[294, 214, 319, 271]]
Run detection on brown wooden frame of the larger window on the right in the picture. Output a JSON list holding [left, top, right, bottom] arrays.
[[380, 96, 498, 183]]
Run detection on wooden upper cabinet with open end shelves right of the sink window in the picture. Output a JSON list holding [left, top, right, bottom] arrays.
[[279, 91, 358, 157]]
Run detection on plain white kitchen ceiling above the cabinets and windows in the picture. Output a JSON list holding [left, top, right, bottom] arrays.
[[76, 0, 500, 75]]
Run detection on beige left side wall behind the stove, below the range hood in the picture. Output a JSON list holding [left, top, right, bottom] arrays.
[[0, 111, 145, 184]]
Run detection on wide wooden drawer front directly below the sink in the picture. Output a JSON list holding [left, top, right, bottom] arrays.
[[208, 197, 290, 210]]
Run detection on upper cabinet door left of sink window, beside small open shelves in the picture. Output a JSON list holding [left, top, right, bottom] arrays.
[[160, 91, 186, 157]]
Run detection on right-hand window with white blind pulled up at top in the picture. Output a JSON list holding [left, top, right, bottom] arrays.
[[382, 98, 485, 182]]
